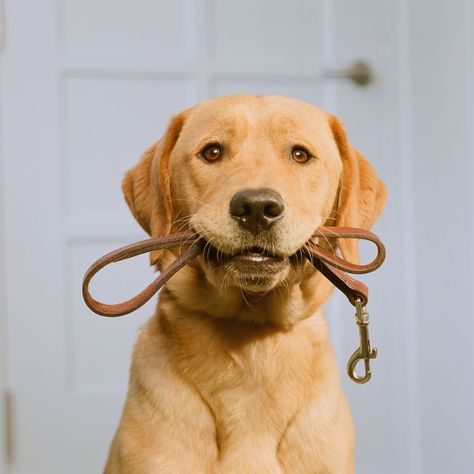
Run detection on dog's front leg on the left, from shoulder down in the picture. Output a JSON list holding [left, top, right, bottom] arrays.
[[104, 320, 218, 474]]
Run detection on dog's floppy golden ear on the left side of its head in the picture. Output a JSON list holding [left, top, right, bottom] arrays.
[[122, 110, 188, 236]]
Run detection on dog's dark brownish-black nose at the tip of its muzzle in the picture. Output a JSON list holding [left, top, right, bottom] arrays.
[[229, 188, 285, 234]]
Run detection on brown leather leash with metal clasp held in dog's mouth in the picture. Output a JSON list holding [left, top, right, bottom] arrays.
[[82, 226, 385, 383]]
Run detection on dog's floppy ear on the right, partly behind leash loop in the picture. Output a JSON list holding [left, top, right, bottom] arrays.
[[330, 117, 387, 262]]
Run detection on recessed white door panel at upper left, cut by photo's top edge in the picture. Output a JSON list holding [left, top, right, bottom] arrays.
[[58, 0, 194, 60]]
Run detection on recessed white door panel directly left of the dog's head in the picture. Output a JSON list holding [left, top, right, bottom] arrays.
[[61, 75, 196, 221]]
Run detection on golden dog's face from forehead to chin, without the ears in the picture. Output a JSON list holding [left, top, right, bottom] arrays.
[[169, 97, 342, 292]]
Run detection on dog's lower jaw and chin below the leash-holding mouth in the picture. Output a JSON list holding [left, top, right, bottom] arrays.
[[203, 247, 292, 293]]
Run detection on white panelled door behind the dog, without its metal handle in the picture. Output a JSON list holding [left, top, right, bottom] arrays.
[[0, 0, 410, 474]]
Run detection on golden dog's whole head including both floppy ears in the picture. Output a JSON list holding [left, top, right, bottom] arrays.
[[123, 96, 385, 302]]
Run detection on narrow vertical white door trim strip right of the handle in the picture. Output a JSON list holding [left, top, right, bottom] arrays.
[[395, 0, 423, 474]]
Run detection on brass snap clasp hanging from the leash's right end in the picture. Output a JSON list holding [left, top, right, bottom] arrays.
[[347, 299, 377, 383]]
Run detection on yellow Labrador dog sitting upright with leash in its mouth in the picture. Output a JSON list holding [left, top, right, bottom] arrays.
[[105, 96, 386, 474]]
